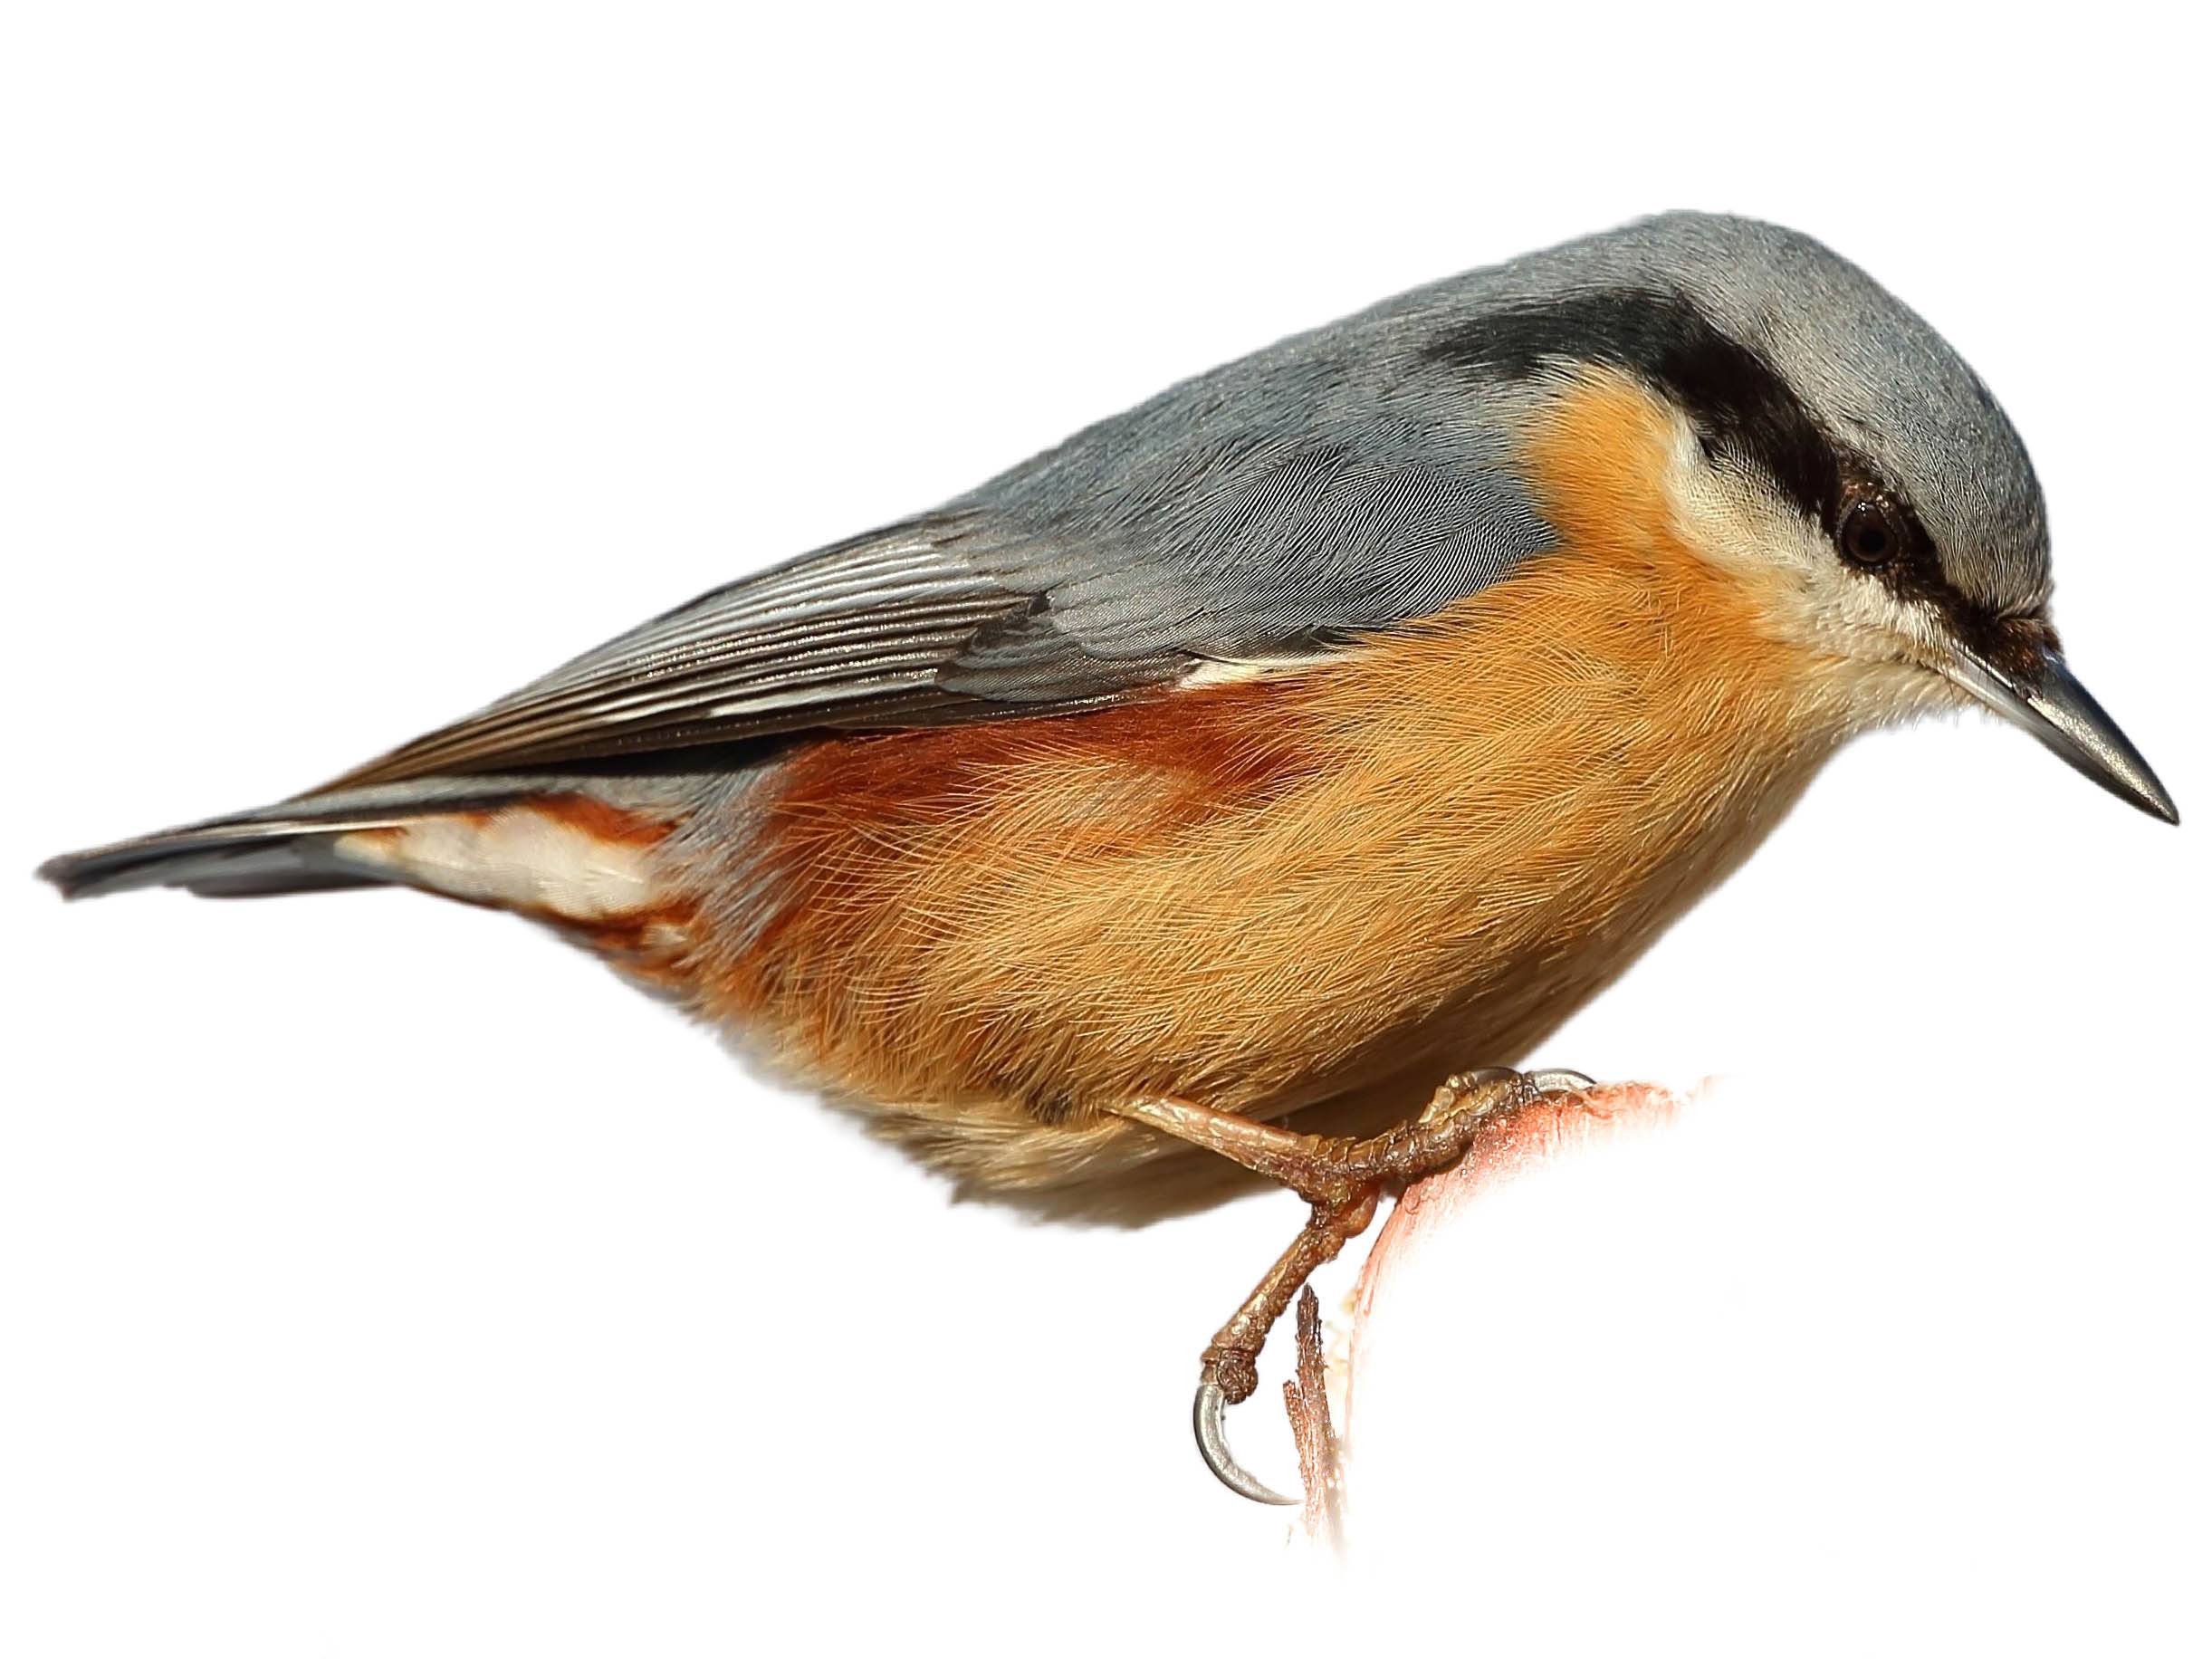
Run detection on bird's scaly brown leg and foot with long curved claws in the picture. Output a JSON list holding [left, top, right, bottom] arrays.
[[1108, 1066, 1591, 1504]]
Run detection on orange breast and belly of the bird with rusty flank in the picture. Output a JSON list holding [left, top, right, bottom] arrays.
[[694, 380, 1841, 1181]]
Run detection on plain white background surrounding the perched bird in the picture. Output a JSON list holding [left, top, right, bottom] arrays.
[[0, 5, 2212, 1657]]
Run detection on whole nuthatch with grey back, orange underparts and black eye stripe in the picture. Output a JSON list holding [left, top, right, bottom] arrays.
[[40, 212, 2178, 1500]]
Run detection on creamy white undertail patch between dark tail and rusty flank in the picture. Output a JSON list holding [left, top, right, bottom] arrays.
[[334, 808, 657, 923]]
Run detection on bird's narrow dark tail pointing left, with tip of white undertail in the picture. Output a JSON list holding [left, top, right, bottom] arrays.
[[38, 779, 610, 898]]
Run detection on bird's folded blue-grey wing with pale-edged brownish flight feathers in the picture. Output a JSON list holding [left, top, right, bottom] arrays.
[[325, 343, 1553, 788]]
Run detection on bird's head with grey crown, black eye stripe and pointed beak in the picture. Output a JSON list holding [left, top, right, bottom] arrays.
[[1427, 212, 2178, 823]]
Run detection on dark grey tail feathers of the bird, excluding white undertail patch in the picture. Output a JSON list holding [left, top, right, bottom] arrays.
[[38, 781, 540, 898]]
